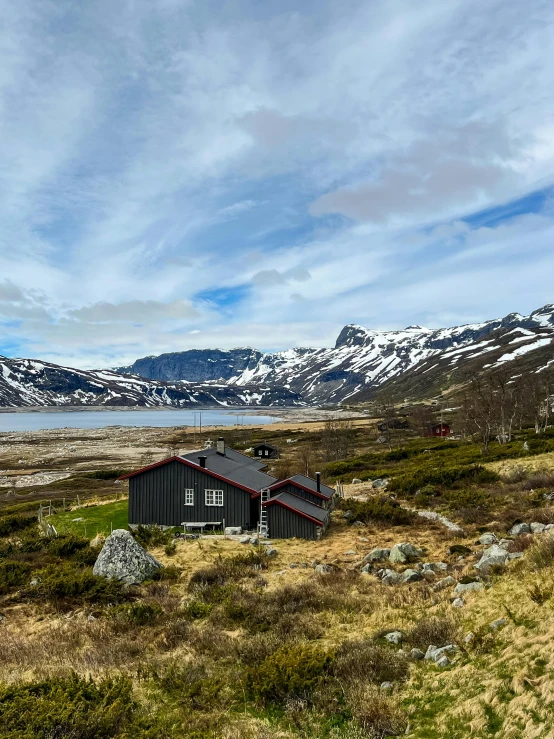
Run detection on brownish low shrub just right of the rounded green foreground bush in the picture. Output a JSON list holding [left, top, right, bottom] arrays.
[[332, 639, 409, 684]]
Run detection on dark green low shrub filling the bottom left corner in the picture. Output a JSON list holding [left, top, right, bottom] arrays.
[[0, 675, 160, 739]]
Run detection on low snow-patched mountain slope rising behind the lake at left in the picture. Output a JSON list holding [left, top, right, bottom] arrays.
[[0, 357, 302, 408]]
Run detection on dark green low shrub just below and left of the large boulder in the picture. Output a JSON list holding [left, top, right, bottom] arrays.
[[21, 562, 127, 603]]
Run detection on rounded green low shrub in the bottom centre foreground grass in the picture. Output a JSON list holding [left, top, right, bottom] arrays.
[[246, 643, 332, 704]]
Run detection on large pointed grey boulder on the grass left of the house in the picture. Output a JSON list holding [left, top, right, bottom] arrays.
[[93, 529, 163, 585]]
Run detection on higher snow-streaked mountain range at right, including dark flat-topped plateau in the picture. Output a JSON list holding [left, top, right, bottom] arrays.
[[120, 305, 554, 403]]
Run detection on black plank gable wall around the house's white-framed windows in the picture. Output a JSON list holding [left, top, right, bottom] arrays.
[[129, 462, 251, 526]]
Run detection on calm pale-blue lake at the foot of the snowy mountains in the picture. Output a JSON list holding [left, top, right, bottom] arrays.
[[0, 408, 280, 432]]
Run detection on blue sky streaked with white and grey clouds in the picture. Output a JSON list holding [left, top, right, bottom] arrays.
[[0, 0, 554, 367]]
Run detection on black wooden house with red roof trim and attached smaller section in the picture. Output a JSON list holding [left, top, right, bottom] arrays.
[[119, 438, 334, 539]]
